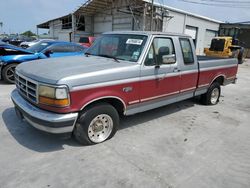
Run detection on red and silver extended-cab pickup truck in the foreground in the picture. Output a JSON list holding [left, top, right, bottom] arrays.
[[11, 32, 238, 144]]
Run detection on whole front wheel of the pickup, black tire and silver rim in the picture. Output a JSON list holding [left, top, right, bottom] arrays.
[[73, 103, 119, 145]]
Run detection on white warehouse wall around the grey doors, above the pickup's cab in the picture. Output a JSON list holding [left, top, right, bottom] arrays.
[[163, 11, 219, 55]]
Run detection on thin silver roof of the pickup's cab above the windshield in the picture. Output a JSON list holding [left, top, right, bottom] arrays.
[[103, 31, 190, 37]]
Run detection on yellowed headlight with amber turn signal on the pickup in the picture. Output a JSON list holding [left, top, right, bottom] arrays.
[[38, 85, 70, 107]]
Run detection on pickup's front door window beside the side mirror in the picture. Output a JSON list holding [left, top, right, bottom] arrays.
[[144, 38, 175, 66]]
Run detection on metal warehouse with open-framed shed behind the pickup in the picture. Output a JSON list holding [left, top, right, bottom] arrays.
[[37, 0, 221, 54]]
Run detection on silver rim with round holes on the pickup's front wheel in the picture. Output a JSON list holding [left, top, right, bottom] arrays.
[[88, 114, 113, 143]]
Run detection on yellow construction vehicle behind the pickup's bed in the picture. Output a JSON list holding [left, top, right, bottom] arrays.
[[204, 36, 244, 63]]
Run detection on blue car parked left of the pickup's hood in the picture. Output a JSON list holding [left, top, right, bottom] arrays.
[[0, 41, 87, 83]]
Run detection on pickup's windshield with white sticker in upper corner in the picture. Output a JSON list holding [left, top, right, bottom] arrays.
[[86, 34, 147, 62]]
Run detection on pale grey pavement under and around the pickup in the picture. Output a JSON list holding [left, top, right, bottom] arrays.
[[0, 61, 250, 188]]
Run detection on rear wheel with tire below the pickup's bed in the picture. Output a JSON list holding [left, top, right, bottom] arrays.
[[201, 82, 221, 105]]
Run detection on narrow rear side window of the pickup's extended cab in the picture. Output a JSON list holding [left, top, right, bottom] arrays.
[[180, 38, 194, 64]]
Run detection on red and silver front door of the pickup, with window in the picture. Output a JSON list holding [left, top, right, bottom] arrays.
[[140, 37, 180, 103]]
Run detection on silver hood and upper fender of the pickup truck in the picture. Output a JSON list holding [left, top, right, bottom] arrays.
[[16, 56, 139, 87]]
